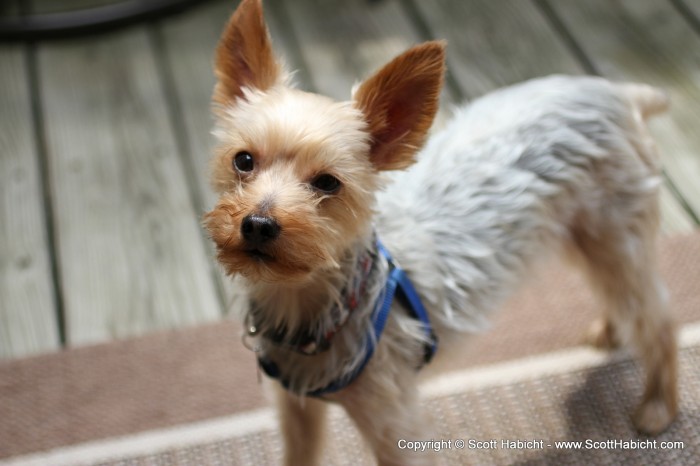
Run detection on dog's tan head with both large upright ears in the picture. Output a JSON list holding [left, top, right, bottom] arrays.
[[205, 0, 445, 282]]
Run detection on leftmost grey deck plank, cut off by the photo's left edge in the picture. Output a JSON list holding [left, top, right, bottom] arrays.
[[0, 45, 60, 358]]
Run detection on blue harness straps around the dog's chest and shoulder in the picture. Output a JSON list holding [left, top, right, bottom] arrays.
[[258, 240, 437, 397]]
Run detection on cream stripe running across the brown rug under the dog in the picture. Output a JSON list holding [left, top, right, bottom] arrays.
[[0, 322, 700, 466]]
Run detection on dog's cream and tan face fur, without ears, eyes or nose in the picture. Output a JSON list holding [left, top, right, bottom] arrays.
[[207, 86, 377, 282]]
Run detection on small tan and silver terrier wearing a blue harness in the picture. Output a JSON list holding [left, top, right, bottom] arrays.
[[204, 0, 677, 465]]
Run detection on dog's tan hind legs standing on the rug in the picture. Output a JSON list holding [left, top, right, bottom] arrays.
[[572, 197, 678, 434]]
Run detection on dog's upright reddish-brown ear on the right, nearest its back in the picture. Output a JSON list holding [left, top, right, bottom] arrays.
[[353, 41, 446, 170]]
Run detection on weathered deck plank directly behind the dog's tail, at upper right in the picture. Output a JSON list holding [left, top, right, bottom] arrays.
[[551, 0, 700, 224]]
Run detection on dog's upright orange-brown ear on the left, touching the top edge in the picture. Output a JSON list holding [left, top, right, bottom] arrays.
[[213, 0, 282, 105]]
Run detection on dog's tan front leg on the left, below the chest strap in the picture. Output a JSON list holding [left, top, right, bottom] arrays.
[[275, 384, 326, 466]]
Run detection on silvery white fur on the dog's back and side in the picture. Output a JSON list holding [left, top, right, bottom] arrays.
[[376, 76, 665, 330]]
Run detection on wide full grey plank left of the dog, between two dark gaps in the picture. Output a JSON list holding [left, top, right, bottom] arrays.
[[39, 27, 221, 345]]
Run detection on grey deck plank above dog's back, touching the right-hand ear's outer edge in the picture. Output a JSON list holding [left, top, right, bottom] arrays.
[[414, 0, 584, 97]]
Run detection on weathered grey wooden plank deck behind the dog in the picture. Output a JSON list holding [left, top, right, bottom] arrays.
[[0, 0, 700, 358]]
